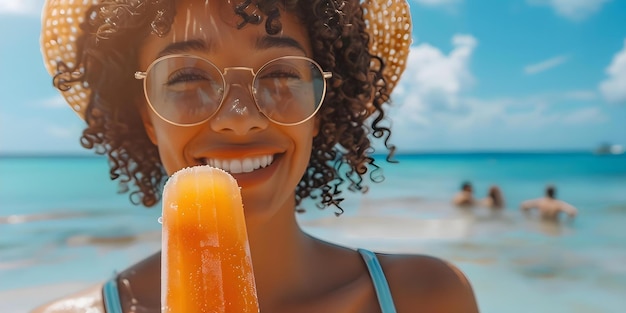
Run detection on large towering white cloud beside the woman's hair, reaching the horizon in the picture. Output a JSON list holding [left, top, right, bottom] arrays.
[[388, 35, 610, 152]]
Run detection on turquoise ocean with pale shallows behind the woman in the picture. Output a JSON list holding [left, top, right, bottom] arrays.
[[0, 152, 626, 313]]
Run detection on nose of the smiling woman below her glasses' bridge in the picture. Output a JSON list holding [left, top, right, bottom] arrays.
[[210, 79, 269, 136]]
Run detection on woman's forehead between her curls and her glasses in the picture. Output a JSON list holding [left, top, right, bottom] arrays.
[[140, 0, 311, 63]]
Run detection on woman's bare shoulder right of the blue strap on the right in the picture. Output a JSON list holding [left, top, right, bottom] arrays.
[[379, 254, 478, 313]]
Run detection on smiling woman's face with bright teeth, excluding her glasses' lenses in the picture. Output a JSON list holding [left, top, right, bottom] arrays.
[[139, 0, 317, 222]]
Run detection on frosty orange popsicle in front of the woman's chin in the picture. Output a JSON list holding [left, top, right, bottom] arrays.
[[161, 166, 259, 313]]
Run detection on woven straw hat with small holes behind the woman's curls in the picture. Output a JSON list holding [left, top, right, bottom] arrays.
[[41, 0, 411, 118]]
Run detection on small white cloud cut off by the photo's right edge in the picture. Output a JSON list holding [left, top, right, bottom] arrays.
[[599, 39, 626, 103]]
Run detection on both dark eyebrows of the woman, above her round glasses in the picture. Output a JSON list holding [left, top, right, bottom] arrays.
[[157, 36, 306, 58]]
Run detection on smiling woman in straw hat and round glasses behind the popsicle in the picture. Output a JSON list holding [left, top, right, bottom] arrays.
[[36, 0, 477, 313]]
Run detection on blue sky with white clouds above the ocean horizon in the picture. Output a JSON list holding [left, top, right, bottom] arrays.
[[0, 0, 626, 154]]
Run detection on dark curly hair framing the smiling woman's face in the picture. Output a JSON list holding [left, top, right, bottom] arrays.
[[54, 0, 395, 214]]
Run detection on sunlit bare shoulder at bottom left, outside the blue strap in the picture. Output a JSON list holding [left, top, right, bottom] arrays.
[[30, 284, 106, 313]]
